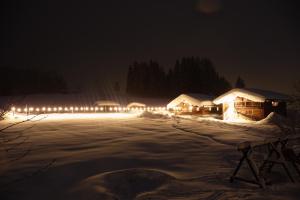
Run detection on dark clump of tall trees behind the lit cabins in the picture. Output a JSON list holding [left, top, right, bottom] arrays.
[[126, 57, 231, 97]]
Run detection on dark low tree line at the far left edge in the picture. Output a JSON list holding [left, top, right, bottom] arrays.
[[0, 67, 67, 96]]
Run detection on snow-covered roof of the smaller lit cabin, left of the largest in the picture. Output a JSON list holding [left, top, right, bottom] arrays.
[[167, 93, 213, 108]]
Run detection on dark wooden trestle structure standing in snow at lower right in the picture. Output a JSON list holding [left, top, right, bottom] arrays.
[[230, 135, 300, 188]]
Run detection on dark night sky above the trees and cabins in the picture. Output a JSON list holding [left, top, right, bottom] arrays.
[[0, 0, 300, 93]]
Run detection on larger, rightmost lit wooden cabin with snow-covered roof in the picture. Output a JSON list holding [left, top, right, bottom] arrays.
[[213, 88, 288, 121]]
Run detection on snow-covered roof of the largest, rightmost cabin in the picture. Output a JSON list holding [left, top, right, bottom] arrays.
[[213, 88, 288, 104]]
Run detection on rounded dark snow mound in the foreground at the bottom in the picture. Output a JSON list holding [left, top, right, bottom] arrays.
[[73, 169, 174, 200]]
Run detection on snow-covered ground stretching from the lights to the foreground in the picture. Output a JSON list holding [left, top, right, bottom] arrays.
[[0, 113, 300, 200]]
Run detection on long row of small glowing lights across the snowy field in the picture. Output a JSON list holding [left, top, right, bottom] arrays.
[[11, 107, 166, 113]]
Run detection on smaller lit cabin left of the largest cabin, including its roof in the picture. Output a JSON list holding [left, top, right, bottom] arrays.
[[167, 93, 221, 114]]
